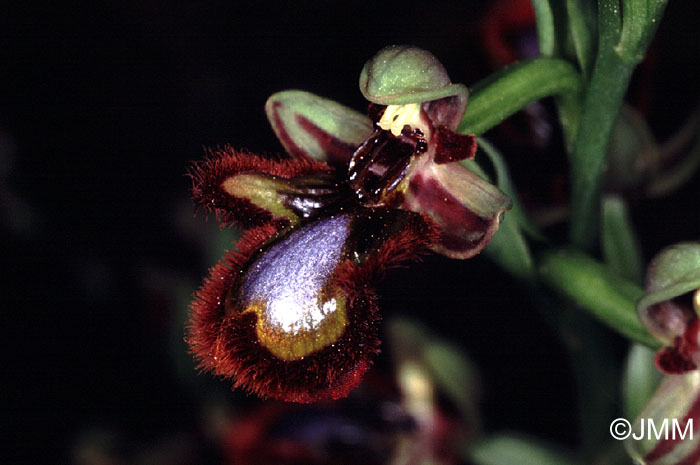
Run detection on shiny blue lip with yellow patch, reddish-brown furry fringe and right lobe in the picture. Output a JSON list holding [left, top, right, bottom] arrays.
[[187, 209, 437, 402]]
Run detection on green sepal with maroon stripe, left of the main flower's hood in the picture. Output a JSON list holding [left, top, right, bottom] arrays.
[[265, 90, 372, 167]]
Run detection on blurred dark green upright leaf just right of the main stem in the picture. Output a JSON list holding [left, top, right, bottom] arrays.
[[602, 196, 643, 283]]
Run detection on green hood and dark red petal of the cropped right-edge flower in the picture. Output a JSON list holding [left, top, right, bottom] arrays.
[[637, 242, 700, 376]]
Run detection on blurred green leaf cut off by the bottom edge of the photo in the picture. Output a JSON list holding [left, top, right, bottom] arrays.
[[465, 434, 579, 465]]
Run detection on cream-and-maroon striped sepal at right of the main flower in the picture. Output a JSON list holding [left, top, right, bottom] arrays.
[[402, 157, 511, 259]]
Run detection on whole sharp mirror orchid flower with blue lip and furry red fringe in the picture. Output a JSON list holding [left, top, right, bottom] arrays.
[[188, 46, 510, 402]]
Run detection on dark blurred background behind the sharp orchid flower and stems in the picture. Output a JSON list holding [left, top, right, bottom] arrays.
[[0, 0, 700, 465]]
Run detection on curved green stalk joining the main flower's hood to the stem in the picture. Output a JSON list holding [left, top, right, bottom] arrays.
[[458, 58, 583, 135]]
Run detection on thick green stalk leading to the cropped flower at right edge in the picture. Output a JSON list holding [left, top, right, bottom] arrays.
[[539, 250, 660, 348]]
